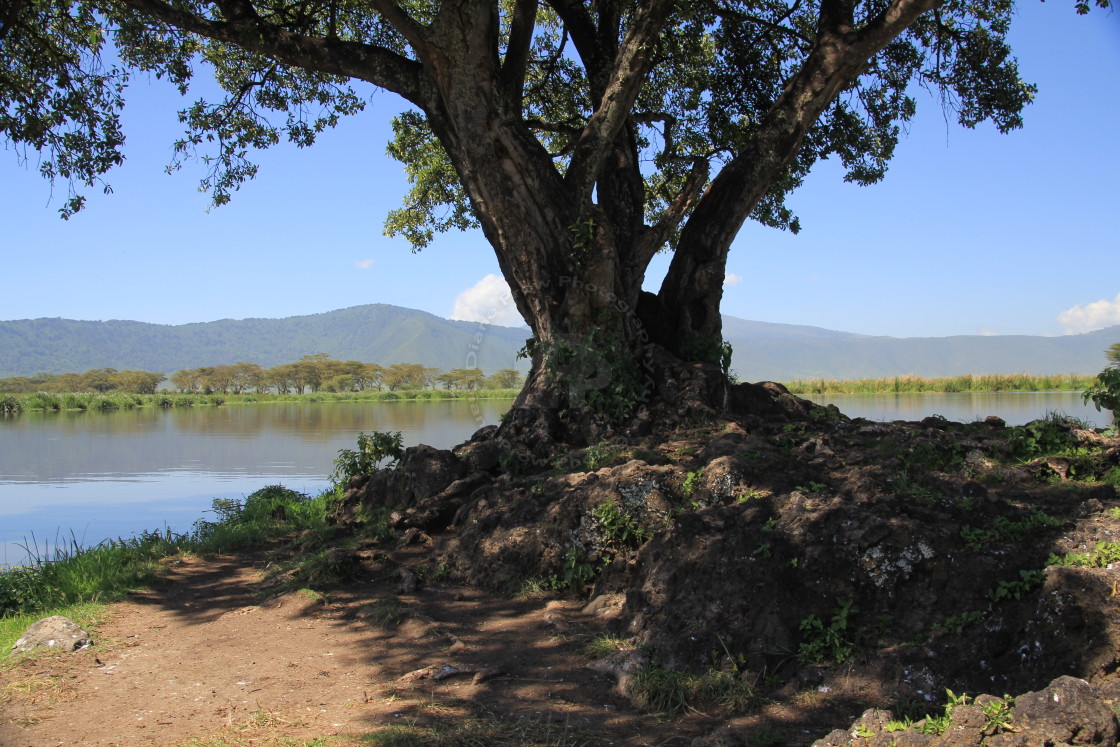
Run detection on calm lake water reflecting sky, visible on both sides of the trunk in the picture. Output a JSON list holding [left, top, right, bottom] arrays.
[[0, 392, 1110, 563]]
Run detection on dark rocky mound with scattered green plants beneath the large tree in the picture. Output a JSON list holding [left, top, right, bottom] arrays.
[[329, 384, 1120, 745]]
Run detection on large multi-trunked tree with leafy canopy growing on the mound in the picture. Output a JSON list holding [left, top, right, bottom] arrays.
[[0, 0, 1108, 432]]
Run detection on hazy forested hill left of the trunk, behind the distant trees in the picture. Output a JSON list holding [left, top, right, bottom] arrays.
[[0, 304, 529, 377]]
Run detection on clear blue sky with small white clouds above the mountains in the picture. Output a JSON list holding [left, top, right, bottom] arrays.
[[0, 0, 1120, 337]]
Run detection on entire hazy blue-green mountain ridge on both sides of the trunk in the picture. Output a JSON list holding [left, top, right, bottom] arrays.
[[0, 304, 1120, 381]]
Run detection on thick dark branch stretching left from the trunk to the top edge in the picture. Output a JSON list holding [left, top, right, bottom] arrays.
[[116, 0, 421, 105]]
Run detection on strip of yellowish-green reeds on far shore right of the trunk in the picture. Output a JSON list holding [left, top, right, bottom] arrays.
[[785, 374, 1095, 394]]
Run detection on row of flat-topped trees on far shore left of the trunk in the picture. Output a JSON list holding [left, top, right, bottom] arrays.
[[0, 353, 522, 394]]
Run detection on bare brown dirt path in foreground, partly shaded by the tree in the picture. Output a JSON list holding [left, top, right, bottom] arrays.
[[0, 548, 711, 747]]
